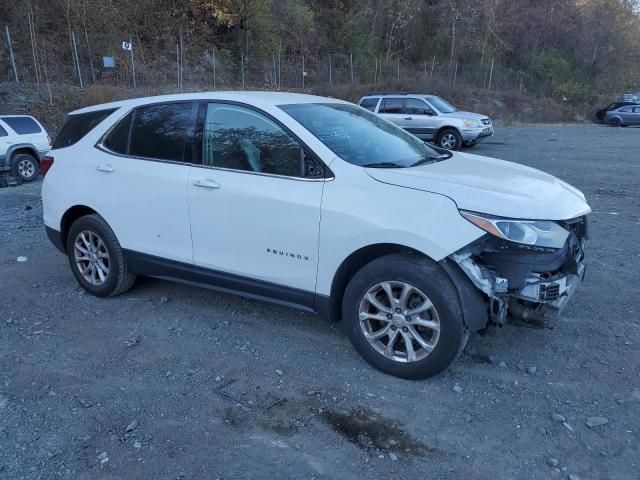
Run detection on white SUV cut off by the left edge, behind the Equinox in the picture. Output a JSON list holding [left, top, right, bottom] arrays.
[[0, 115, 51, 182]]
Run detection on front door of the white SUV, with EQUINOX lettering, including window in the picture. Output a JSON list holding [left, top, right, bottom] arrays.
[[188, 103, 324, 303]]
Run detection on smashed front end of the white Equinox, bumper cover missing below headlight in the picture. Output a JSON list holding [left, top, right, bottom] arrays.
[[450, 220, 587, 327]]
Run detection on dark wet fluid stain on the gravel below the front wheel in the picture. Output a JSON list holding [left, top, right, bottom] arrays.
[[322, 408, 436, 457]]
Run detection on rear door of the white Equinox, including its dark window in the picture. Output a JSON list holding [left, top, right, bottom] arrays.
[[87, 102, 197, 263]]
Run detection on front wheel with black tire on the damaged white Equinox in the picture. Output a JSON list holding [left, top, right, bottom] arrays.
[[342, 254, 468, 380]]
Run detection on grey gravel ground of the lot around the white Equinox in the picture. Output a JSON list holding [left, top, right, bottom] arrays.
[[0, 125, 640, 480]]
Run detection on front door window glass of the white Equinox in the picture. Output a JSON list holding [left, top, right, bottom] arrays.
[[202, 103, 304, 177]]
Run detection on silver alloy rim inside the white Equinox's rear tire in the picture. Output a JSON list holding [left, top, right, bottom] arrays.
[[73, 230, 111, 286]]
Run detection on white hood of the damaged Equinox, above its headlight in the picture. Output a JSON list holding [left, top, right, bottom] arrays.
[[367, 152, 591, 220]]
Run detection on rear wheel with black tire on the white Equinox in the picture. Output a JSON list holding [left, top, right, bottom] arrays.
[[66, 214, 136, 297]]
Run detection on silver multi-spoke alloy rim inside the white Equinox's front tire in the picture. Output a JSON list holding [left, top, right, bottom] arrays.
[[358, 281, 440, 363]]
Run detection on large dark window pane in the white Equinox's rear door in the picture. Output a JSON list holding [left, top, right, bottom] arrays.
[[129, 102, 193, 162]]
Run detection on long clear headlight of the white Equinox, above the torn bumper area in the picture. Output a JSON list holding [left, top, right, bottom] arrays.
[[460, 210, 569, 248]]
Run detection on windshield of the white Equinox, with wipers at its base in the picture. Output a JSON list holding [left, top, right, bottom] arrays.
[[280, 103, 439, 167]]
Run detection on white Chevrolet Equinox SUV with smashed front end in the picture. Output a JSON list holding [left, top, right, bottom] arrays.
[[42, 92, 590, 378]]
